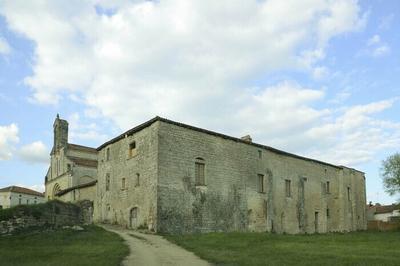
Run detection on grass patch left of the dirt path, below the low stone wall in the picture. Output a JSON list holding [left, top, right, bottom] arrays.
[[0, 226, 129, 266]]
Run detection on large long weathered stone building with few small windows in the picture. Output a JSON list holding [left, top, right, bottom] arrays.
[[46, 114, 366, 233]]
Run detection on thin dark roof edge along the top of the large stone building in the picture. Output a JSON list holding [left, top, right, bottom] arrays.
[[97, 116, 363, 173]]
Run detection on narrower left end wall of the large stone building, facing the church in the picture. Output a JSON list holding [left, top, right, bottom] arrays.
[[94, 123, 158, 229]]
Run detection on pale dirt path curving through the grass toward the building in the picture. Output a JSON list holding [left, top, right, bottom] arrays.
[[101, 225, 210, 266]]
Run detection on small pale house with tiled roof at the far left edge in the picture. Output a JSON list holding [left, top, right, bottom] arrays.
[[0, 186, 45, 209]]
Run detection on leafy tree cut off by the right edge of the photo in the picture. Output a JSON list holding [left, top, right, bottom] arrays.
[[381, 153, 400, 195]]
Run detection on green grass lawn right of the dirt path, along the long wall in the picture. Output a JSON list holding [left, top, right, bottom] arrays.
[[165, 231, 400, 265]]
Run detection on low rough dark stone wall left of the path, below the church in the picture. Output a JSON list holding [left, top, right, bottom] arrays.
[[0, 201, 93, 235]]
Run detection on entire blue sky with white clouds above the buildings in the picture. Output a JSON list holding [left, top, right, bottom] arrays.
[[0, 0, 400, 204]]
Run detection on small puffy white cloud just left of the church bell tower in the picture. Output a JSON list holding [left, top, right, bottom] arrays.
[[18, 141, 50, 164]]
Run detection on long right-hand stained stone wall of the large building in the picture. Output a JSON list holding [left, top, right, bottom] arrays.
[[157, 122, 366, 233]]
